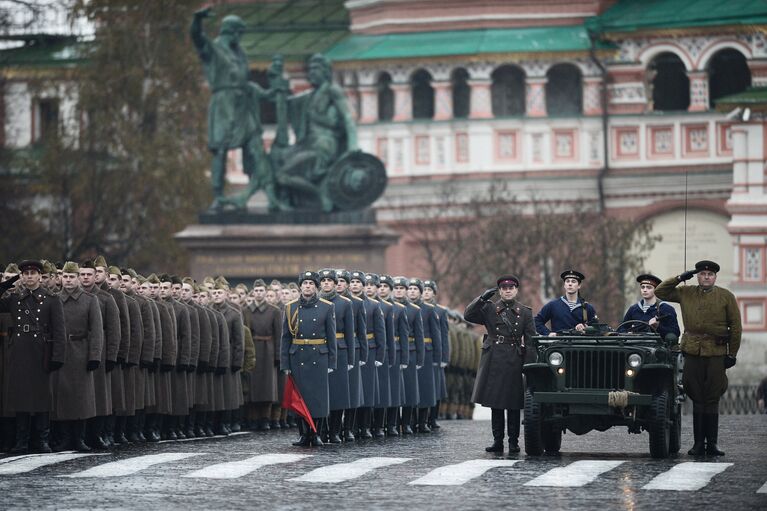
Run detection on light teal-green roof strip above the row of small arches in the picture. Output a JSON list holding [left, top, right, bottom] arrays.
[[326, 25, 604, 62]]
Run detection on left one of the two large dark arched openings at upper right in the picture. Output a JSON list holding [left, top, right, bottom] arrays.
[[650, 52, 690, 112]]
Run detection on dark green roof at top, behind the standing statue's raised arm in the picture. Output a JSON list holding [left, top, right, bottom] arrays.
[[222, 0, 349, 61]]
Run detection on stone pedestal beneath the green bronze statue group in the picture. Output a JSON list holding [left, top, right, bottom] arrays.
[[175, 213, 399, 285]]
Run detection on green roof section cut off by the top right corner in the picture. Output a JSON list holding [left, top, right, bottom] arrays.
[[587, 0, 767, 33]]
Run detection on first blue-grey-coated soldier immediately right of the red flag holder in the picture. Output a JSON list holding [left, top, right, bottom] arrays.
[[320, 268, 358, 444]]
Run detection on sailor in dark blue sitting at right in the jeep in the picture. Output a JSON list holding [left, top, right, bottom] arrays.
[[618, 273, 679, 339]]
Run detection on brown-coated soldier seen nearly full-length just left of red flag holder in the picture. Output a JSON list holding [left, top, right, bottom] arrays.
[[244, 279, 282, 431]]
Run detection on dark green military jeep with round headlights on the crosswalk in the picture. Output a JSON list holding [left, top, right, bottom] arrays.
[[523, 322, 684, 458]]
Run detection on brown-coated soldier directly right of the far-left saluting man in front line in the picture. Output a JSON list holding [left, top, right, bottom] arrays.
[[52, 262, 104, 452]]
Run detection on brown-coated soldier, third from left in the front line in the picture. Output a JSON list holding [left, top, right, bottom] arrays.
[[80, 261, 121, 449]]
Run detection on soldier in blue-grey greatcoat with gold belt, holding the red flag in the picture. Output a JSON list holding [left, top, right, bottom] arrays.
[[280, 271, 337, 446]]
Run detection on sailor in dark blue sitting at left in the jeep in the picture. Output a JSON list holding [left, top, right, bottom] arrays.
[[535, 270, 597, 337]]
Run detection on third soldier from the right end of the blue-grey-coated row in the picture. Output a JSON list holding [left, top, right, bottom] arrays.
[[392, 277, 425, 435]]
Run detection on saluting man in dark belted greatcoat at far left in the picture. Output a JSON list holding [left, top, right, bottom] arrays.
[[0, 261, 66, 453]]
